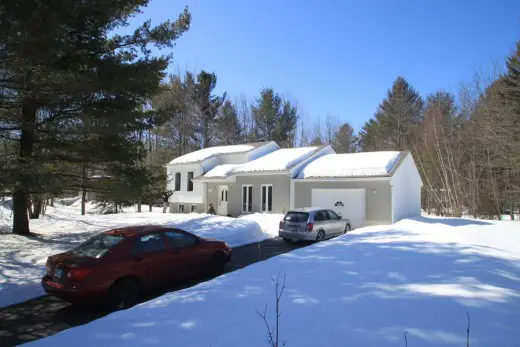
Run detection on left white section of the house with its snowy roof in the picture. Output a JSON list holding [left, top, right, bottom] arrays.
[[166, 141, 279, 213]]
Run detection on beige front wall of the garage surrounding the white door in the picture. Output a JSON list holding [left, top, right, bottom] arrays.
[[294, 180, 392, 226]]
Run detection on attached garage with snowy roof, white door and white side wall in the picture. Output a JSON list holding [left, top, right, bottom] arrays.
[[290, 151, 422, 228]]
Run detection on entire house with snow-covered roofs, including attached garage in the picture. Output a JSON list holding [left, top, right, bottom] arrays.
[[167, 142, 422, 227]]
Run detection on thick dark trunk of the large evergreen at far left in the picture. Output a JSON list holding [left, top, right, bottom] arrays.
[[13, 88, 36, 235]]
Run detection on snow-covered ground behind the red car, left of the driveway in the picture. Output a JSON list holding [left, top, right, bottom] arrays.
[[0, 203, 282, 307]]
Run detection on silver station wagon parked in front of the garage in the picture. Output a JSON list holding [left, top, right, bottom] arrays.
[[278, 208, 352, 242]]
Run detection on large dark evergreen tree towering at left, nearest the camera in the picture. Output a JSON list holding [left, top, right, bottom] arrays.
[[0, 0, 190, 234]]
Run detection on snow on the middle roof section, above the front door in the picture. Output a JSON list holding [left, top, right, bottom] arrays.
[[233, 147, 318, 173]]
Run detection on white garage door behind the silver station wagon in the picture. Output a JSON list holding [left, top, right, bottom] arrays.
[[312, 189, 365, 228]]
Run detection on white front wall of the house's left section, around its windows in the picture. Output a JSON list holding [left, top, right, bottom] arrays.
[[166, 164, 204, 205]]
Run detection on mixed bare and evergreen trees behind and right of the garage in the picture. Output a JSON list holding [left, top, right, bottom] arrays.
[[359, 46, 520, 219]]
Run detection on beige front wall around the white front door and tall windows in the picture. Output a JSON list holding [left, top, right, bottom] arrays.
[[206, 174, 290, 217]]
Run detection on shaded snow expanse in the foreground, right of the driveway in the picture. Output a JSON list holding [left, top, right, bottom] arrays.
[[26, 217, 520, 347]]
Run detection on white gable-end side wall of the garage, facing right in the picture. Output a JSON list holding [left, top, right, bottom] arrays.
[[390, 154, 422, 223]]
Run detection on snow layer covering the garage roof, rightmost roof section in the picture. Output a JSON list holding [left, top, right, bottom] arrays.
[[298, 151, 401, 178]]
